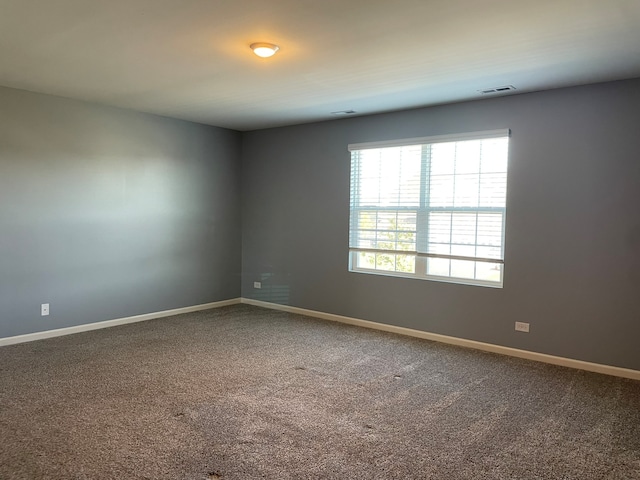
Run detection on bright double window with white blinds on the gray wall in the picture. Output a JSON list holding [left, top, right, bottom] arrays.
[[349, 130, 509, 287]]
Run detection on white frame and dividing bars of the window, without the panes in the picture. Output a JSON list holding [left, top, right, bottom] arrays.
[[348, 129, 511, 288]]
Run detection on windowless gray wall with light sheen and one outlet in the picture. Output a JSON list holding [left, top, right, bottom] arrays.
[[0, 88, 241, 337]]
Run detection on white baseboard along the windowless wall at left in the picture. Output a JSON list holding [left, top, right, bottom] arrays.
[[0, 298, 240, 347]]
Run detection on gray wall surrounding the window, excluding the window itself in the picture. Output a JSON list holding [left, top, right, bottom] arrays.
[[242, 80, 640, 369]]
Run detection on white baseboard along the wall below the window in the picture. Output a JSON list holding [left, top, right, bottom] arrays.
[[241, 298, 640, 380]]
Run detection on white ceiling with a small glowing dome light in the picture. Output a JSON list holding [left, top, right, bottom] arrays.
[[0, 0, 640, 130]]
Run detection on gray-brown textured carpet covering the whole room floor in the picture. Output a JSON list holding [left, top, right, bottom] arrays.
[[0, 305, 640, 480]]
